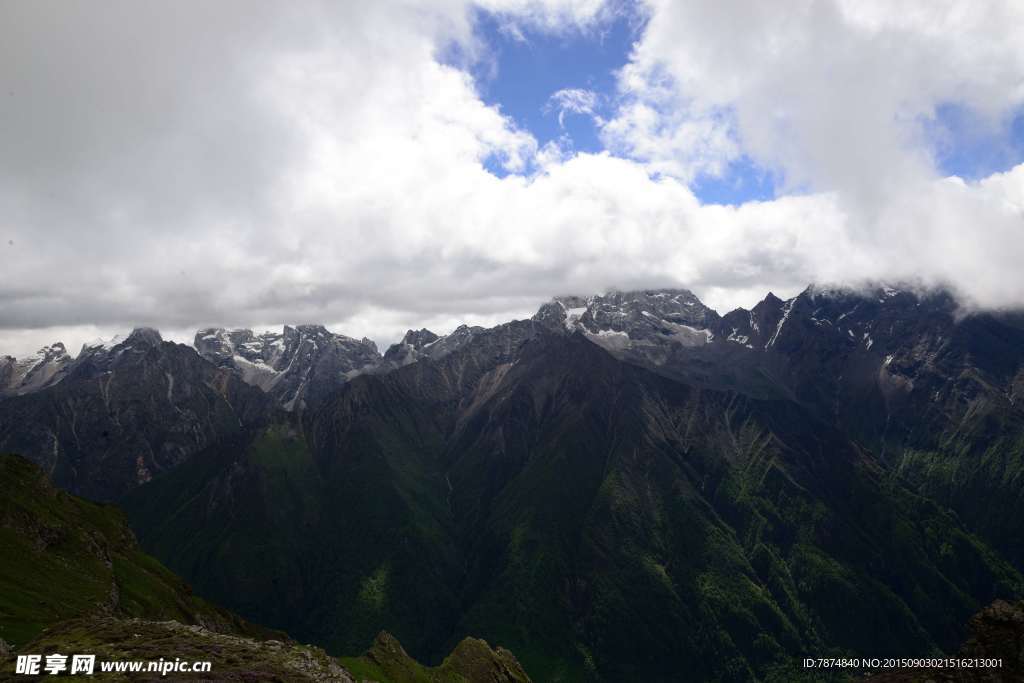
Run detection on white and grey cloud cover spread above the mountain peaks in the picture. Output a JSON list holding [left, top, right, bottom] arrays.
[[0, 0, 1024, 352]]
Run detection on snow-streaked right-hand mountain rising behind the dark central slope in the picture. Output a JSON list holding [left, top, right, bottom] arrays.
[[536, 287, 1024, 566]]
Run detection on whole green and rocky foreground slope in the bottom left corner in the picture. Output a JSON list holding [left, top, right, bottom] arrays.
[[0, 454, 529, 683]]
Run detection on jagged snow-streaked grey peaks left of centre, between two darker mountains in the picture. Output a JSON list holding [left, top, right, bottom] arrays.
[[195, 325, 381, 411]]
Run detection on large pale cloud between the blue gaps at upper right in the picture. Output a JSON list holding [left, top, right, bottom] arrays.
[[610, 0, 1024, 197]]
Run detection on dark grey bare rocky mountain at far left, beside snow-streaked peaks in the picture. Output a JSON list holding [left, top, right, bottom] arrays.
[[0, 329, 272, 500]]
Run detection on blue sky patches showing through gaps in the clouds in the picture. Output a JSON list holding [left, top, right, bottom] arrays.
[[462, 10, 1024, 205]]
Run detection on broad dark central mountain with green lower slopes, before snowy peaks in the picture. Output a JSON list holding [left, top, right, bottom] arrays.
[[121, 323, 1021, 680]]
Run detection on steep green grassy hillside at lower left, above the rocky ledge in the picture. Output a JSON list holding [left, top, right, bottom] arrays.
[[0, 455, 272, 647]]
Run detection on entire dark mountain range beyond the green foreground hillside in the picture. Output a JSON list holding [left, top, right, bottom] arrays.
[[0, 286, 1024, 681]]
